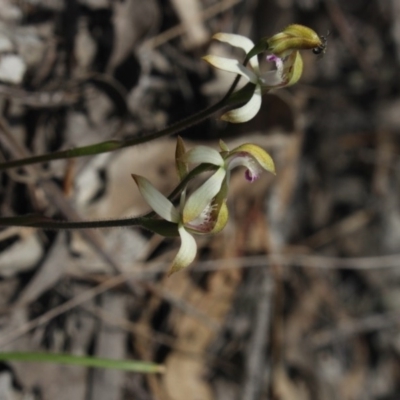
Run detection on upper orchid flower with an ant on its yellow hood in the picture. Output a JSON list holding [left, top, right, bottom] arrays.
[[203, 24, 326, 123]]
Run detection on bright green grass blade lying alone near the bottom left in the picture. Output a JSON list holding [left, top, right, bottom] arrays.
[[0, 352, 164, 374]]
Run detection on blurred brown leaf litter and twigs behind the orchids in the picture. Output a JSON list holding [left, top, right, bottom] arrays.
[[0, 0, 400, 400]]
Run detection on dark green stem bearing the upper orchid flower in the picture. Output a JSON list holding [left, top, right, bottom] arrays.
[[0, 79, 252, 171]]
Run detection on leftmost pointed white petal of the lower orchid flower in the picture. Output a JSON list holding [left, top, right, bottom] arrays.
[[132, 175, 179, 223]]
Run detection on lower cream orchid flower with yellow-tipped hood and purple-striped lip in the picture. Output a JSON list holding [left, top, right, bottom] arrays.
[[132, 137, 275, 275]]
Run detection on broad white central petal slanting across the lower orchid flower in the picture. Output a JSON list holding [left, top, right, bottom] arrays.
[[182, 168, 226, 224]]
